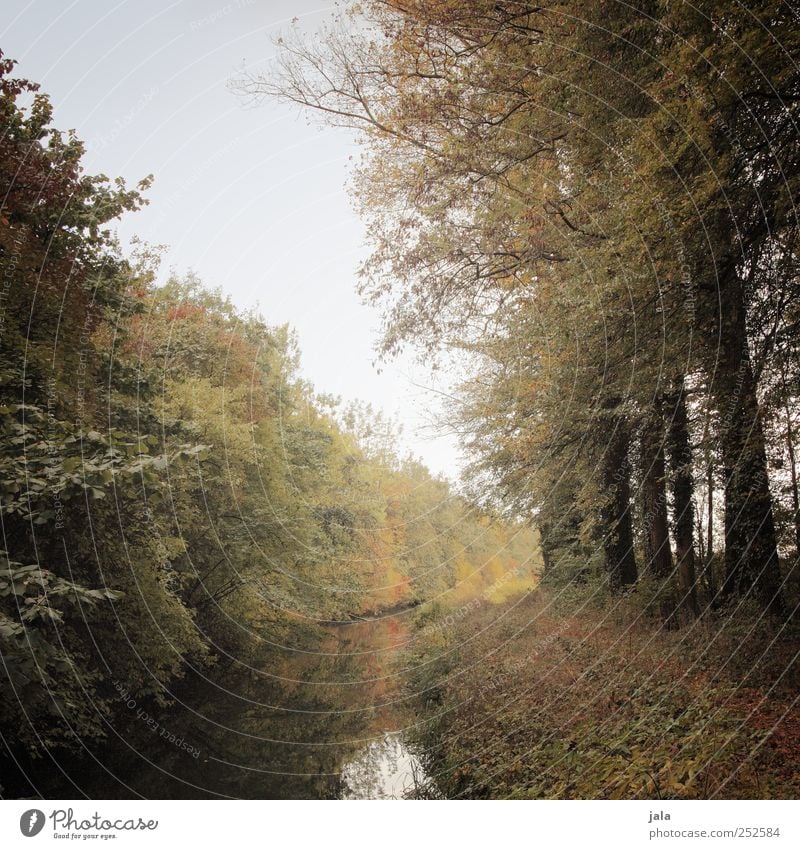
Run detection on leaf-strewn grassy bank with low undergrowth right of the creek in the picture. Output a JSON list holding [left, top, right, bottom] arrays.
[[409, 586, 800, 799]]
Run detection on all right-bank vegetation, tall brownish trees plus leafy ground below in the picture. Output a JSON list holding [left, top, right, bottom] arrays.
[[252, 0, 800, 797]]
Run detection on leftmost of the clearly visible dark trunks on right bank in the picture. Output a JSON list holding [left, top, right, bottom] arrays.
[[600, 416, 637, 592]]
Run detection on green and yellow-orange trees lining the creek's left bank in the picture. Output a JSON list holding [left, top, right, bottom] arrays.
[[0, 48, 534, 776]]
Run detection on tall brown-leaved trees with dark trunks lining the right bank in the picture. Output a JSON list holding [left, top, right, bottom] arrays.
[[256, 0, 800, 615]]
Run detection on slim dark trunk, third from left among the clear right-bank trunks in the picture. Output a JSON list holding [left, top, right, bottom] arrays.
[[669, 379, 699, 616]]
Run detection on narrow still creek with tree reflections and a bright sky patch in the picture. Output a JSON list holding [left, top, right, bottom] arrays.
[[12, 611, 434, 799]]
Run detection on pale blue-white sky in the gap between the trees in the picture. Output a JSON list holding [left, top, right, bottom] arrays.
[[0, 0, 460, 478]]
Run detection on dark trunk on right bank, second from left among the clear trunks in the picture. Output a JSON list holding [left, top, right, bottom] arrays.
[[641, 402, 672, 578]]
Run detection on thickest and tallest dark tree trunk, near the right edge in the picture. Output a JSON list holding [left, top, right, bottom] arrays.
[[712, 274, 782, 612]]
